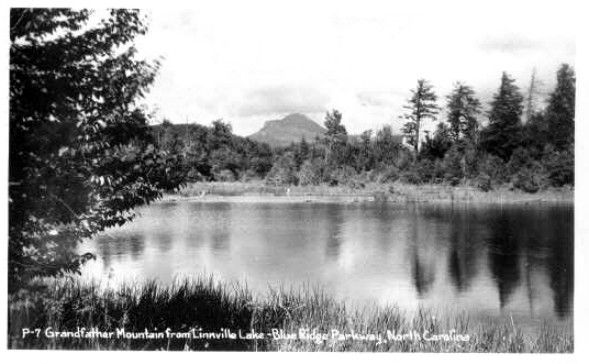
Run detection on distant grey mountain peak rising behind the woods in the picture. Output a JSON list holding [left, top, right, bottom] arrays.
[[249, 113, 326, 147]]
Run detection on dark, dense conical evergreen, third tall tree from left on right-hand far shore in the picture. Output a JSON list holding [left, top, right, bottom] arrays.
[[481, 72, 523, 162]]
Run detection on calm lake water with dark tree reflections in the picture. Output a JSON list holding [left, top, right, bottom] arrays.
[[83, 201, 574, 322]]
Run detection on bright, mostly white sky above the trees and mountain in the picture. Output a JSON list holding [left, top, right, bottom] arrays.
[[132, 0, 575, 136]]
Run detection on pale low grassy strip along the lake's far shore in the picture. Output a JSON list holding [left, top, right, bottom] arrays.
[[165, 181, 574, 204]]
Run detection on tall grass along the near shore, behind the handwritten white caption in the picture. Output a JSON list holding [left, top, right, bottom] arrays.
[[8, 278, 573, 352]]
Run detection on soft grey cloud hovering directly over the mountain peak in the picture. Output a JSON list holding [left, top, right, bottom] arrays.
[[237, 86, 329, 117]]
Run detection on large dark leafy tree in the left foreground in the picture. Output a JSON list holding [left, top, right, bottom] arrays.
[[9, 9, 182, 291]]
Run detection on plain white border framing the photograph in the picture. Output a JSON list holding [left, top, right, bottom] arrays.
[[0, 0, 589, 364]]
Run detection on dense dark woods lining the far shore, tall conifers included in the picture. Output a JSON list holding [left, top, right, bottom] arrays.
[[154, 64, 575, 193]]
